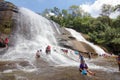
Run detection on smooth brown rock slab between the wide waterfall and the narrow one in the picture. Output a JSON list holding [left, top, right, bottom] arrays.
[[58, 28, 96, 53]]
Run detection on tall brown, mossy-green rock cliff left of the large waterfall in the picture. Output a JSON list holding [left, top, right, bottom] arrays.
[[0, 0, 18, 54]]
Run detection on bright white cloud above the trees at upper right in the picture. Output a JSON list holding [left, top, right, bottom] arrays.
[[80, 0, 120, 18]]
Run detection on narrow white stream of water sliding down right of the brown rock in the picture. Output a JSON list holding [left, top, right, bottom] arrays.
[[66, 28, 105, 55]]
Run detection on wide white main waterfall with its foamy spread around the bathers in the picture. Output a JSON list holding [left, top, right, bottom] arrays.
[[2, 8, 79, 65]]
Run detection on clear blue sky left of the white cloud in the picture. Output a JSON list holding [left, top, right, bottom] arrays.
[[5, 0, 95, 12]]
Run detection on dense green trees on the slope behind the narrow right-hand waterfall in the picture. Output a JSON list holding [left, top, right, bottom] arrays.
[[42, 4, 120, 54]]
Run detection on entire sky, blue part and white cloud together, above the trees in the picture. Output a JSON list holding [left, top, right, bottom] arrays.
[[5, 0, 120, 18]]
